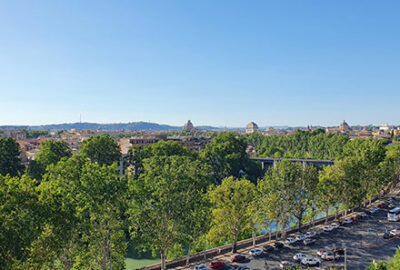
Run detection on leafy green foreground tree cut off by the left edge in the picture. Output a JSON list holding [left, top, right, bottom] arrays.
[[0, 175, 46, 269]]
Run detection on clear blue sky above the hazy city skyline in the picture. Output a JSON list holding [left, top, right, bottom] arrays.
[[0, 0, 400, 127]]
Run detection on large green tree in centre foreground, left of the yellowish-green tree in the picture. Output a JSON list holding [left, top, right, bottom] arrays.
[[127, 155, 209, 269]]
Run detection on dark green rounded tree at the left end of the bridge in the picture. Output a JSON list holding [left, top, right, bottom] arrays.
[[200, 132, 262, 184]]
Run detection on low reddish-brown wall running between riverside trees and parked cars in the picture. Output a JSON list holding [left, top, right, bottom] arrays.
[[138, 190, 389, 270]]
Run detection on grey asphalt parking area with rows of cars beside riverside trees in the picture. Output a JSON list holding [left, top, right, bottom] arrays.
[[189, 195, 400, 270]]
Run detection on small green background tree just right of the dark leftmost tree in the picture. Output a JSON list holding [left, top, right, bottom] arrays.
[[27, 140, 72, 180]]
